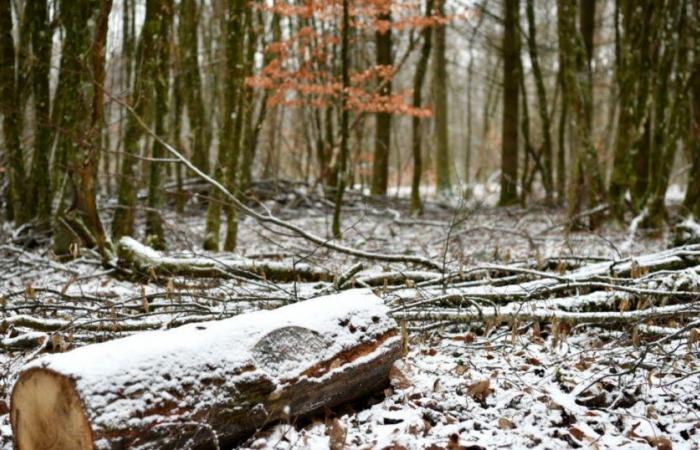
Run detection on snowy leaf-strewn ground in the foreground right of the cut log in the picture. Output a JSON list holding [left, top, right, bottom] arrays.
[[247, 329, 700, 449]]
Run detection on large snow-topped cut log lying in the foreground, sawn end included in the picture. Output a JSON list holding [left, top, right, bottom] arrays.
[[10, 290, 401, 450]]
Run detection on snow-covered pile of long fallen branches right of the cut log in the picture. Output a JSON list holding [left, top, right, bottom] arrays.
[[391, 245, 700, 330]]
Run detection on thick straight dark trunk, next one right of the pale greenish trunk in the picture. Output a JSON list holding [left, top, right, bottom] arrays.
[[498, 0, 522, 206]]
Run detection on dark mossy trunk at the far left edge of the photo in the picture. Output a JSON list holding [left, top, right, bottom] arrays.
[[0, 0, 31, 225]]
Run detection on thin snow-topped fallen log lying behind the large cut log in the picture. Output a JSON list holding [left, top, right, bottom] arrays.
[[118, 236, 333, 282]]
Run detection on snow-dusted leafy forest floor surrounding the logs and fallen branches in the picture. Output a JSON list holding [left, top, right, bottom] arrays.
[[0, 182, 700, 450]]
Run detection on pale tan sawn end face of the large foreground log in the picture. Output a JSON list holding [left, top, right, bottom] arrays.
[[10, 369, 93, 450]]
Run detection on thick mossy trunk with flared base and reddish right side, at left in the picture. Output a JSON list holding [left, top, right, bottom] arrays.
[[54, 0, 114, 260]]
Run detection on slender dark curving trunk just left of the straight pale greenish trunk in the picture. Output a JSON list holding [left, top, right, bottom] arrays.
[[411, 0, 433, 214]]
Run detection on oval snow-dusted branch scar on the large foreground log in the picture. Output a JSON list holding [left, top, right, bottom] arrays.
[[252, 326, 331, 379]]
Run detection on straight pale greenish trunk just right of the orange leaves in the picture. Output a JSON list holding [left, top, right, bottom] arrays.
[[433, 0, 452, 191]]
